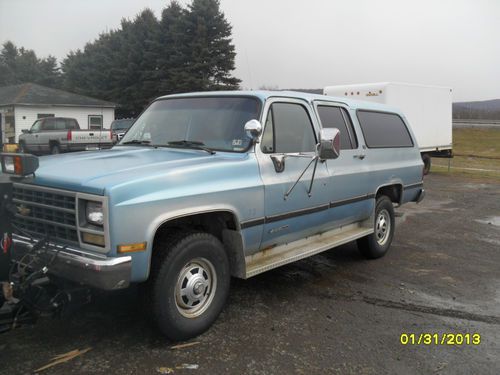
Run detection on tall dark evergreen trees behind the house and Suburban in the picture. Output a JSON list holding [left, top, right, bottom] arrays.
[[0, 0, 240, 116]]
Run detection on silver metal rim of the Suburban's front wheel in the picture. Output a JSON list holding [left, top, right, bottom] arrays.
[[175, 258, 217, 318]]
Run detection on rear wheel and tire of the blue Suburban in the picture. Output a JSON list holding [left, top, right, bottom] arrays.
[[358, 195, 395, 259]]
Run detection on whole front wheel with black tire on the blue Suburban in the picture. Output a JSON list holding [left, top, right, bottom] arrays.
[[149, 233, 230, 341]]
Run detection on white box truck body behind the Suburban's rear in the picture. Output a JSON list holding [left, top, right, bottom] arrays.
[[323, 82, 453, 174]]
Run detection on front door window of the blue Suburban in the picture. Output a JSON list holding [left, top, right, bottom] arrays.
[[261, 103, 316, 154]]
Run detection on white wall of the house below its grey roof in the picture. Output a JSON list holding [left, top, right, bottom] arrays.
[[15, 105, 115, 142]]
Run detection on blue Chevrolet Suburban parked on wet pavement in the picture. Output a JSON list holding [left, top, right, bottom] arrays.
[[2, 91, 424, 340]]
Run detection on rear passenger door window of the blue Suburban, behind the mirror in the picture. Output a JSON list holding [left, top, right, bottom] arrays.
[[318, 105, 358, 150]]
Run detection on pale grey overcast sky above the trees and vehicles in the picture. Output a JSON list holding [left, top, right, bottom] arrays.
[[0, 0, 500, 101]]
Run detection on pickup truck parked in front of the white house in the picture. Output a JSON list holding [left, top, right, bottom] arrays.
[[19, 117, 113, 154]]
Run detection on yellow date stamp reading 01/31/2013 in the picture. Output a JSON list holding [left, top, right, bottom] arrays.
[[399, 333, 481, 346]]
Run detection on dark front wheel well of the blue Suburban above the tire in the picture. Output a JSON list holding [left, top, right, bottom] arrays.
[[151, 211, 245, 277]]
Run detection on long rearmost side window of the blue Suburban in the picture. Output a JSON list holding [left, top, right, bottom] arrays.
[[357, 111, 413, 148]]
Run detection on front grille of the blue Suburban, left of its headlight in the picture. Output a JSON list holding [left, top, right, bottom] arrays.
[[13, 184, 78, 243]]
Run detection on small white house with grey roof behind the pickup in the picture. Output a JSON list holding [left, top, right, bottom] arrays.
[[0, 83, 117, 143]]
